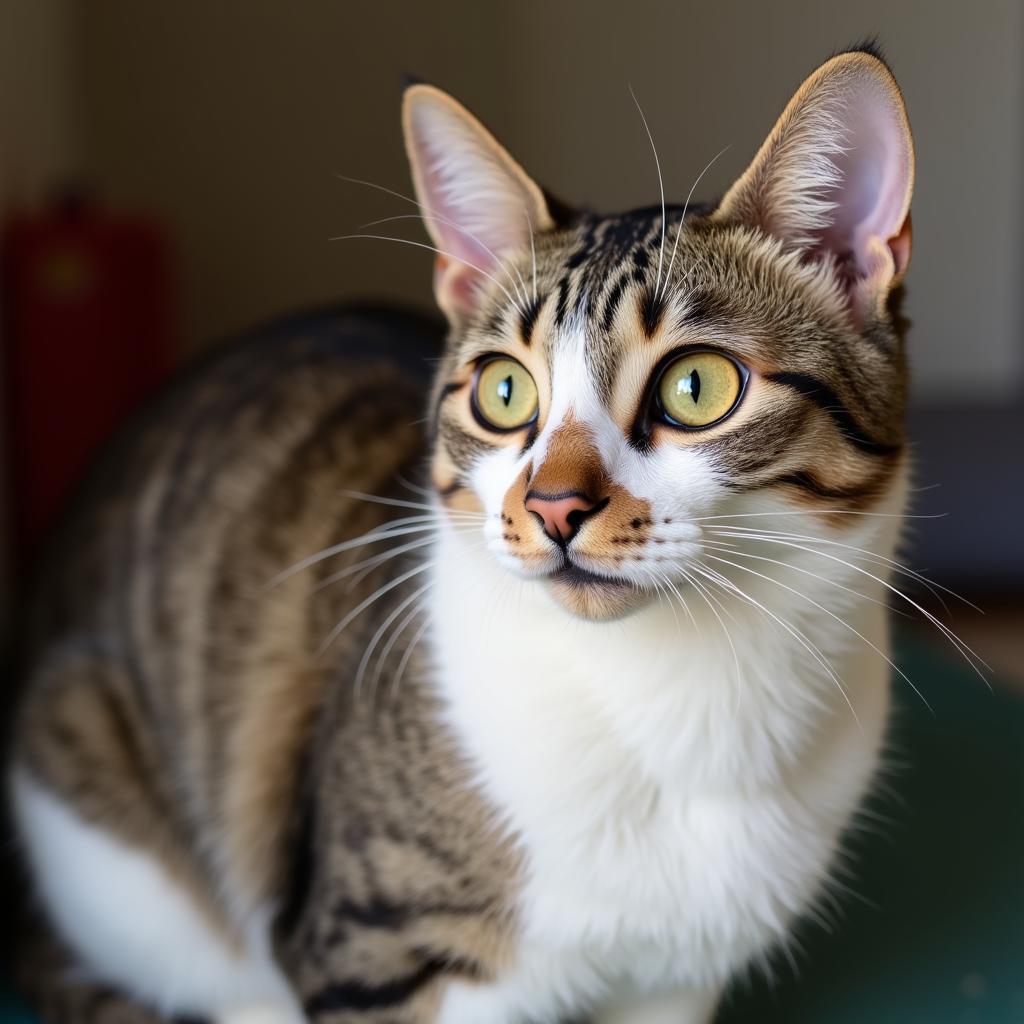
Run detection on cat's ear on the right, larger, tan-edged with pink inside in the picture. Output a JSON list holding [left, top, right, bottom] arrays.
[[715, 50, 913, 325]]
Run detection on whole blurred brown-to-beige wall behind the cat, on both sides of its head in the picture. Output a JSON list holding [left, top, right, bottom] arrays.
[[66, 0, 1024, 403]]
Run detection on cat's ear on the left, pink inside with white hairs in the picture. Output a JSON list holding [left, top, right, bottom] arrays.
[[402, 84, 553, 324]]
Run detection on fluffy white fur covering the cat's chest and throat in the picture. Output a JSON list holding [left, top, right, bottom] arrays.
[[434, 537, 888, 1020]]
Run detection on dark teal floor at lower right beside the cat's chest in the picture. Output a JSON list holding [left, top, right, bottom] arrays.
[[0, 642, 1024, 1024]]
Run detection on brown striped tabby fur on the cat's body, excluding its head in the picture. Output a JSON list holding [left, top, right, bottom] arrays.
[[16, 315, 515, 1024]]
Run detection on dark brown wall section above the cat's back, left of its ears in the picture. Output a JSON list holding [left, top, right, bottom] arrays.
[[77, 0, 511, 345]]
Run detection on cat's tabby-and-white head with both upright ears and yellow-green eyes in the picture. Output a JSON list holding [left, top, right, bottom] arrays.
[[404, 51, 913, 618]]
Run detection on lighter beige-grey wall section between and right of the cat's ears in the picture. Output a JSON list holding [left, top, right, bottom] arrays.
[[501, 0, 1024, 403]]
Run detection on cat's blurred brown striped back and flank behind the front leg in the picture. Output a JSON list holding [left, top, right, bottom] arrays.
[[15, 310, 440, 921]]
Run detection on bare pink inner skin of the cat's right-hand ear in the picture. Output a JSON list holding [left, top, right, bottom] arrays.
[[821, 85, 911, 276]]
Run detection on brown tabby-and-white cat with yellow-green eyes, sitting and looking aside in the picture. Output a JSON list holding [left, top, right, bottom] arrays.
[[10, 48, 913, 1024]]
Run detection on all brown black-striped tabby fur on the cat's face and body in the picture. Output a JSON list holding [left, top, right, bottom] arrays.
[[4, 46, 905, 1024]]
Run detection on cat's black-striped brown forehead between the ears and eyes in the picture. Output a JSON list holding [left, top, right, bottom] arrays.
[[457, 207, 852, 385]]
